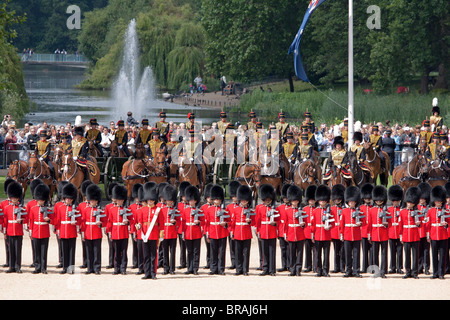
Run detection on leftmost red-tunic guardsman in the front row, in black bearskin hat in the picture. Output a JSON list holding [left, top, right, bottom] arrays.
[[3, 181, 28, 273]]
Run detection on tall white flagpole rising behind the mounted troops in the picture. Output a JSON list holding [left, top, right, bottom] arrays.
[[348, 0, 354, 149]]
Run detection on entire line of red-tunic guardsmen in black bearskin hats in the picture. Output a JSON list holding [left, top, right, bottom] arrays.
[[0, 179, 450, 279]]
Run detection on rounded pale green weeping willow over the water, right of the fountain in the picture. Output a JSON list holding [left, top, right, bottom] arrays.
[[167, 23, 205, 88]]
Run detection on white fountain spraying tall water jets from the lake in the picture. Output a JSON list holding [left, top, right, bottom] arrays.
[[112, 19, 156, 121]]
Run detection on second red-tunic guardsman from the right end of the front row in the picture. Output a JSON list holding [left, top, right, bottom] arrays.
[[398, 187, 423, 279]]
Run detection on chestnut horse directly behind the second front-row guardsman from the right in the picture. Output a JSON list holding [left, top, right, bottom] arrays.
[[392, 152, 429, 191]]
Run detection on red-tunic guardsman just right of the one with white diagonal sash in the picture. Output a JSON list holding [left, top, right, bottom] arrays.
[[161, 185, 181, 274]]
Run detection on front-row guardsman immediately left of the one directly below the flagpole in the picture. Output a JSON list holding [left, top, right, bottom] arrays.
[[311, 185, 336, 277]]
